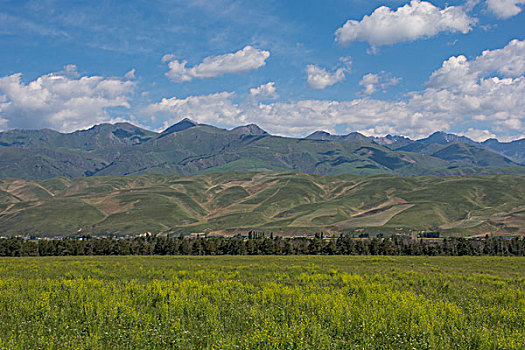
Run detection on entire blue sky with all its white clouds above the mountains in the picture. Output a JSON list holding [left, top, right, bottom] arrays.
[[0, 0, 525, 141]]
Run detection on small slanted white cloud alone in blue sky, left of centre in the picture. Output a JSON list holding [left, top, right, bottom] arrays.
[[162, 46, 270, 82]]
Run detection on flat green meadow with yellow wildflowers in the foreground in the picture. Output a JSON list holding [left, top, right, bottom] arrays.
[[0, 256, 525, 349]]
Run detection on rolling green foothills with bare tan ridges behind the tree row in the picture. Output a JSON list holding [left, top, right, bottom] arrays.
[[0, 172, 525, 236]]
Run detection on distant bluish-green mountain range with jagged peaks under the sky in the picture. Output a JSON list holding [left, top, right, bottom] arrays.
[[0, 119, 525, 179]]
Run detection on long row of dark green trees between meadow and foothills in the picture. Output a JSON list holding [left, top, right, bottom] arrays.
[[0, 236, 525, 256]]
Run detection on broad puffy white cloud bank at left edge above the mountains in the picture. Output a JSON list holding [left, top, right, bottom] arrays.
[[0, 65, 135, 131]]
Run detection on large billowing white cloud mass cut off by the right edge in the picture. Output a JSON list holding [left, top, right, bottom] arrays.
[[426, 40, 525, 123]]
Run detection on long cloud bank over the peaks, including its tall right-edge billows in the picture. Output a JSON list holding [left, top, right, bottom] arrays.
[[146, 41, 525, 140]]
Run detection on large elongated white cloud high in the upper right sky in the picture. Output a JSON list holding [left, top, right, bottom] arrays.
[[335, 0, 476, 47]]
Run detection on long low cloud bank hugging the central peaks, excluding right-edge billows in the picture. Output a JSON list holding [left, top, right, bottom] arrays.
[[143, 92, 430, 137]]
